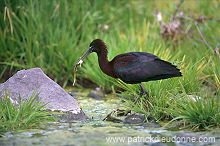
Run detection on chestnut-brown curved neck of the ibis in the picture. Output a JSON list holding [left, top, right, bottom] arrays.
[[97, 49, 117, 78]]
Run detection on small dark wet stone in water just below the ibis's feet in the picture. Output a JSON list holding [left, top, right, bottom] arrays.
[[124, 113, 146, 124]]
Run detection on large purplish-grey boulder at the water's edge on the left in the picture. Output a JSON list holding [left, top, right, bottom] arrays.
[[0, 68, 88, 120]]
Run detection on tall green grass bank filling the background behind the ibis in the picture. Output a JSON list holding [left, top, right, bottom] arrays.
[[0, 0, 220, 127]]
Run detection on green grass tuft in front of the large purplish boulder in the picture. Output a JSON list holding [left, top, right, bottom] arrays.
[[0, 90, 56, 132]]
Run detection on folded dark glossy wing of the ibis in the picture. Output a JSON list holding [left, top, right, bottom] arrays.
[[112, 52, 181, 83]]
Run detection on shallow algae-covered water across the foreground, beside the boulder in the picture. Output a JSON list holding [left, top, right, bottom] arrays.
[[0, 89, 220, 146]]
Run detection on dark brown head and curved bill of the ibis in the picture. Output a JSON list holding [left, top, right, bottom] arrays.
[[80, 39, 107, 60]]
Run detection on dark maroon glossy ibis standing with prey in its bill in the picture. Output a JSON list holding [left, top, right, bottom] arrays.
[[77, 39, 182, 104]]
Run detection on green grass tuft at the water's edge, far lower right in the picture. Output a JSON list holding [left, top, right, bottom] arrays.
[[164, 96, 220, 129]]
